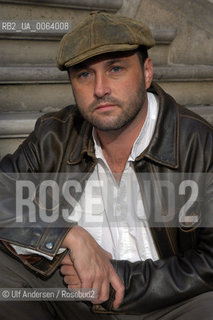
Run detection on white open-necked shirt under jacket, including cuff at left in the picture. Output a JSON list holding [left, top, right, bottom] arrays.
[[12, 93, 159, 262]]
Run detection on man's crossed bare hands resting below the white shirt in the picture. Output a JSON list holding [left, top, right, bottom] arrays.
[[61, 226, 124, 308]]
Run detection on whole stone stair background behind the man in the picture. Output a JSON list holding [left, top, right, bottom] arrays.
[[0, 0, 213, 158]]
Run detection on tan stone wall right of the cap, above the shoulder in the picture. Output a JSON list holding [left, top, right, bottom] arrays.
[[120, 0, 213, 110]]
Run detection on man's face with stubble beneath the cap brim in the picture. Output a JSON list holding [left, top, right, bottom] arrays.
[[70, 53, 152, 131]]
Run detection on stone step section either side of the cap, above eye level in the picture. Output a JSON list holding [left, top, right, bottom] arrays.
[[0, 29, 176, 67]]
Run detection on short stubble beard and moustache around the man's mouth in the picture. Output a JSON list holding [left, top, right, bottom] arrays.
[[74, 79, 146, 131]]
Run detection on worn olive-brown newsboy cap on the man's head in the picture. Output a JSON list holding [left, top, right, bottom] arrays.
[[57, 11, 155, 70]]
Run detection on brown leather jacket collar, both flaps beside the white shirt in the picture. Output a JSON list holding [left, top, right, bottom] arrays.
[[68, 82, 179, 168]]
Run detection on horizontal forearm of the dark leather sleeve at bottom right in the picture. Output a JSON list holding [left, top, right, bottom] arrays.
[[107, 228, 213, 314]]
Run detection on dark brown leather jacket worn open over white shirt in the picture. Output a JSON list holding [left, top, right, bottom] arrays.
[[0, 83, 213, 314]]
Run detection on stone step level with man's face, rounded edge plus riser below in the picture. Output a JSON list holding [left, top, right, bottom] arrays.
[[0, 65, 213, 112]]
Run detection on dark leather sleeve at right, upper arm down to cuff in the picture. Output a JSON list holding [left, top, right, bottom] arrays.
[[93, 144, 213, 314]]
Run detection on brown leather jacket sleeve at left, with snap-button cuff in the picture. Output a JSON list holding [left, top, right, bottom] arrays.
[[0, 119, 72, 275]]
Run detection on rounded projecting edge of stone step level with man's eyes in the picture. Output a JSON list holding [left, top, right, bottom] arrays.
[[0, 65, 213, 84]]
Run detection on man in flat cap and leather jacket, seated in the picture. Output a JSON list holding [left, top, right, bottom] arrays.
[[0, 12, 213, 319]]
